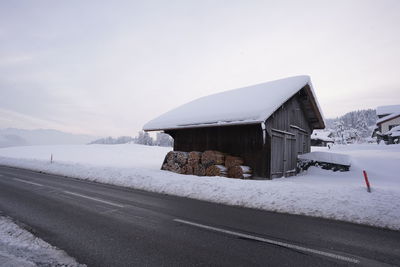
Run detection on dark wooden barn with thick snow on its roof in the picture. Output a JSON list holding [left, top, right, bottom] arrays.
[[143, 76, 325, 178]]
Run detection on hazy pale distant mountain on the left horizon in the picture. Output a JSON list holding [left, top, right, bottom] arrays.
[[0, 128, 96, 147]]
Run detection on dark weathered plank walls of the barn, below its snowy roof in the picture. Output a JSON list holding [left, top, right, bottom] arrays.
[[165, 88, 316, 178]]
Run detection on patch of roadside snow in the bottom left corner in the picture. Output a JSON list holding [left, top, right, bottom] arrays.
[[0, 215, 86, 267]]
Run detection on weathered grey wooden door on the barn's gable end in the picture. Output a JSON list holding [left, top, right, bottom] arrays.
[[271, 129, 297, 178]]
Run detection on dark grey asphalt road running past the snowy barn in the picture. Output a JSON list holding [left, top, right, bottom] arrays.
[[0, 166, 400, 266]]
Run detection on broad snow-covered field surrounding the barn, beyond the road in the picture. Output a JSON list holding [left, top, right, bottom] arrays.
[[0, 144, 400, 230]]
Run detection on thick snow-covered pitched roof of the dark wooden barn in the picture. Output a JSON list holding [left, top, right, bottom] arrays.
[[143, 76, 325, 131]]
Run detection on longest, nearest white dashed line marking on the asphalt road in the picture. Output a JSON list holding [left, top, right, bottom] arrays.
[[174, 219, 360, 264]]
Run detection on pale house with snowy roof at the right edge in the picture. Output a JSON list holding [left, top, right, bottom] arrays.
[[372, 105, 400, 144]]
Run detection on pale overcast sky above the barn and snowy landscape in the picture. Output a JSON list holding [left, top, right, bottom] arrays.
[[0, 0, 400, 136]]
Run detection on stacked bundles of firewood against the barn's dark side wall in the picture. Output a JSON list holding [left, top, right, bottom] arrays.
[[161, 150, 252, 179]]
